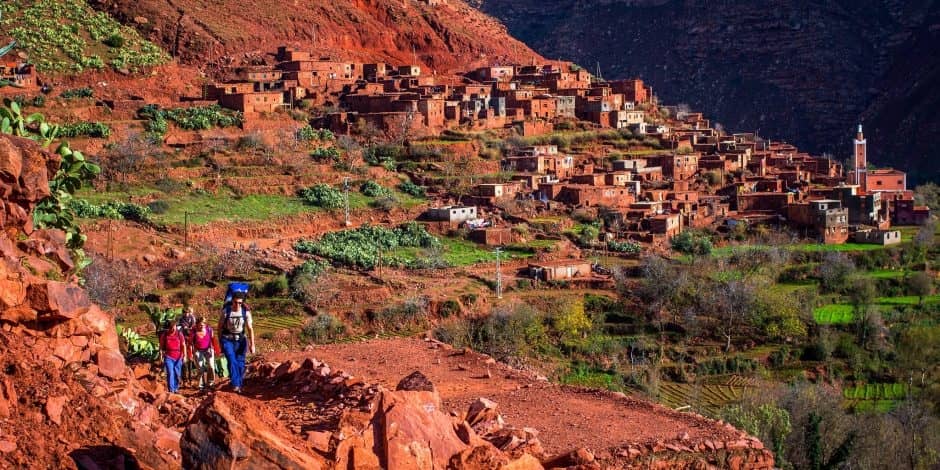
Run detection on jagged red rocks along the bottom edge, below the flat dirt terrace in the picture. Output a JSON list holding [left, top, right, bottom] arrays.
[[181, 359, 774, 470]]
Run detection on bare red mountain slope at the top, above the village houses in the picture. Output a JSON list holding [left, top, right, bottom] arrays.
[[93, 0, 538, 72]]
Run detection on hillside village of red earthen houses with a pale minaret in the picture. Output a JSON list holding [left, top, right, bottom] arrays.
[[0, 46, 930, 279]]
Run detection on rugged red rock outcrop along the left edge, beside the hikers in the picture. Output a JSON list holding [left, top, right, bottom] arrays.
[[0, 135, 188, 469]]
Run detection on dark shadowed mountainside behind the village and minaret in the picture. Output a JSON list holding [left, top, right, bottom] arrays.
[[474, 0, 940, 180]]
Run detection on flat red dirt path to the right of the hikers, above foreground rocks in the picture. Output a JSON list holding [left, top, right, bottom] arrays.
[[266, 338, 735, 455]]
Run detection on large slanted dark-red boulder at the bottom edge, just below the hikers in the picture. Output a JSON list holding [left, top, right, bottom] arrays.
[[180, 393, 329, 470]]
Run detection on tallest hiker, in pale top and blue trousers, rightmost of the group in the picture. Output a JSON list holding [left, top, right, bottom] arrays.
[[218, 287, 255, 393]]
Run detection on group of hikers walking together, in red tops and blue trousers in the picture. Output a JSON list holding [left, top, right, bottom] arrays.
[[160, 282, 255, 393]]
